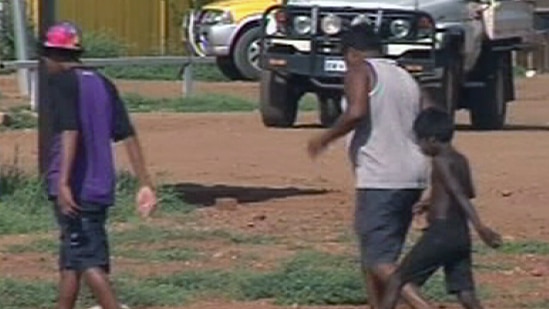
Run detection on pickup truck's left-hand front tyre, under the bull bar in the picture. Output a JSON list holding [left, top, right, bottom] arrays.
[[259, 71, 303, 128]]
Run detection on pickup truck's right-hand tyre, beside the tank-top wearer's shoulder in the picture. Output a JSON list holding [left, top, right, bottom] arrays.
[[470, 57, 507, 130]]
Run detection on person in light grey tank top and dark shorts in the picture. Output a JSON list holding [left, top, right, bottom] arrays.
[[308, 24, 428, 309]]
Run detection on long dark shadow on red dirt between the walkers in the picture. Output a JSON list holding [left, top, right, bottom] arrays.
[[167, 183, 329, 207]]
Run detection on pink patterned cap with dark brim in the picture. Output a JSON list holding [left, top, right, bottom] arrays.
[[42, 22, 83, 52]]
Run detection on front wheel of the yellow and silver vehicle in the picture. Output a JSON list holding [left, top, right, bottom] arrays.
[[233, 27, 261, 80]]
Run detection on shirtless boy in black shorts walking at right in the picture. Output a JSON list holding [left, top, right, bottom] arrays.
[[381, 108, 501, 309]]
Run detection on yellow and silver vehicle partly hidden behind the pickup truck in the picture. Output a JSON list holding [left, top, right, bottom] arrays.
[[184, 0, 282, 80]]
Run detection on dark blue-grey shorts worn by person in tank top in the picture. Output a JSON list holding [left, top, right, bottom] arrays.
[[355, 189, 423, 268]]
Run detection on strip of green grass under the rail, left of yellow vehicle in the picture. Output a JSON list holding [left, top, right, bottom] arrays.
[[101, 64, 229, 82]]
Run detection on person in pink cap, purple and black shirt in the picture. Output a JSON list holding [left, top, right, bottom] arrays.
[[42, 22, 157, 309]]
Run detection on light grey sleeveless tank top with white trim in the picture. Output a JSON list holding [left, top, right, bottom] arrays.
[[342, 59, 428, 189]]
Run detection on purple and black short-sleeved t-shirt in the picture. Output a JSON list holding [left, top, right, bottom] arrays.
[[46, 68, 134, 206]]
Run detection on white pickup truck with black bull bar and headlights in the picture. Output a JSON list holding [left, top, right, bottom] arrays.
[[260, 0, 535, 130]]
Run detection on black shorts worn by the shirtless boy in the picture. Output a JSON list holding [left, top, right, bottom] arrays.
[[397, 220, 475, 294]]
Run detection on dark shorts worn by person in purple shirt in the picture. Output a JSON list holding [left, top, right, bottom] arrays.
[[55, 204, 110, 273]]
